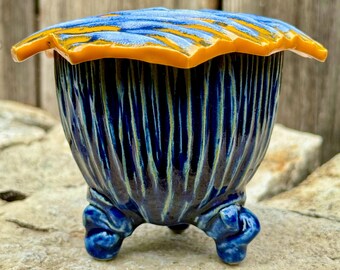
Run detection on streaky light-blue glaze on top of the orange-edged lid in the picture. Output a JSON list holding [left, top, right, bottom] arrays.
[[42, 8, 309, 48]]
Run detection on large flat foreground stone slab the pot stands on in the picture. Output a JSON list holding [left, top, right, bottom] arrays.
[[0, 186, 340, 270]]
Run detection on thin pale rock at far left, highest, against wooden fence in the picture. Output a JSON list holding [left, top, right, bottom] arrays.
[[0, 100, 57, 130]]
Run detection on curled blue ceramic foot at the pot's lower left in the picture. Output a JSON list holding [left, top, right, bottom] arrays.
[[83, 191, 135, 260]]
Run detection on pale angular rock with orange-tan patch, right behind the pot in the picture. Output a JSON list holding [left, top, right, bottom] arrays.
[[247, 125, 322, 202]]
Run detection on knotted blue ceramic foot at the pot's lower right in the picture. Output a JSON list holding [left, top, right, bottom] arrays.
[[203, 205, 260, 264]]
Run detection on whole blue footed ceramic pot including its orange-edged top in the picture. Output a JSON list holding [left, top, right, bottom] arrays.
[[12, 8, 327, 264]]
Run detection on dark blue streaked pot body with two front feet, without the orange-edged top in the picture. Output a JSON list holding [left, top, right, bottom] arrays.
[[55, 53, 282, 263]]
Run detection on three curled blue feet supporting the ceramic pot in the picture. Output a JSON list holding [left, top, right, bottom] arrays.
[[83, 190, 260, 264]]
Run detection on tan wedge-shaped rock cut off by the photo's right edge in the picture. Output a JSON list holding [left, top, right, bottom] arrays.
[[264, 154, 340, 222]]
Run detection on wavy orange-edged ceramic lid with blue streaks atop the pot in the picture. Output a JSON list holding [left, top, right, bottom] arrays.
[[12, 8, 327, 68]]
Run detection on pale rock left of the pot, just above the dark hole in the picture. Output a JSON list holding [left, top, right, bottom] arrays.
[[0, 126, 84, 196]]
